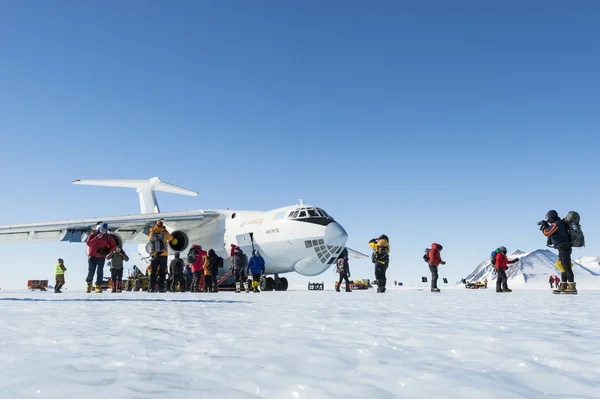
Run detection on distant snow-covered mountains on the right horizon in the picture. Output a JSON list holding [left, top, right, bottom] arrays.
[[457, 249, 600, 286]]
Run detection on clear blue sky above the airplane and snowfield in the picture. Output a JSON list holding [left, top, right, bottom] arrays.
[[0, 0, 600, 289]]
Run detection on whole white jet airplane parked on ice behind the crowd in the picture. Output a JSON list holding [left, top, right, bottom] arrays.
[[0, 177, 368, 291]]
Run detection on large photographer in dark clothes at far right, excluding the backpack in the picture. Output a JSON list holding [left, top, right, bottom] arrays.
[[540, 209, 577, 294]]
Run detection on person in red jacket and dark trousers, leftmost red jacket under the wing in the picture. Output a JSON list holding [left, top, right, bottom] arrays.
[[85, 223, 117, 293]]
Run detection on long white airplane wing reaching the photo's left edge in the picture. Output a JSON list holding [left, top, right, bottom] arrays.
[[0, 210, 219, 243]]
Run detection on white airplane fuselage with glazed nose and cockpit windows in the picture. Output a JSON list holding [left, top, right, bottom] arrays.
[[157, 205, 348, 276]]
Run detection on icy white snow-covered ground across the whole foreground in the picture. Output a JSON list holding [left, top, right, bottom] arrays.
[[0, 287, 600, 399]]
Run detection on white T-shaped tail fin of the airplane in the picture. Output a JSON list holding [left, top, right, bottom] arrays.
[[73, 177, 198, 213]]
